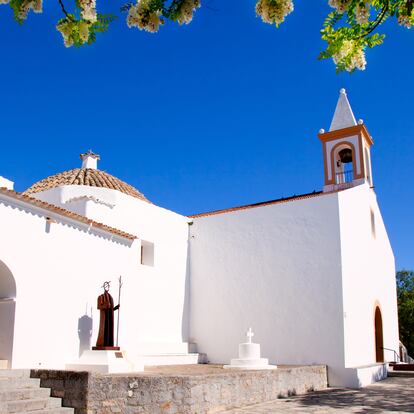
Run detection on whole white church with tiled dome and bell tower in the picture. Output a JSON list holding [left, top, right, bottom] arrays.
[[0, 90, 399, 387]]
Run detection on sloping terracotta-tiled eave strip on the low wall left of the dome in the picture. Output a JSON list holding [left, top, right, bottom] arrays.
[[0, 187, 138, 240]]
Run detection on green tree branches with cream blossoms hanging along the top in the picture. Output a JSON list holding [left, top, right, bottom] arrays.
[[0, 0, 414, 72]]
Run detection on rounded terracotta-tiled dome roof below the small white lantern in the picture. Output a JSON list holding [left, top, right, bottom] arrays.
[[23, 168, 149, 203]]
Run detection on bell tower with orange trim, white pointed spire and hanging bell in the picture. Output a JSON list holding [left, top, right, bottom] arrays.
[[318, 89, 374, 192]]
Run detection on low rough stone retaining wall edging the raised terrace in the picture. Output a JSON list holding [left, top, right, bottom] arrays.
[[32, 366, 327, 414]]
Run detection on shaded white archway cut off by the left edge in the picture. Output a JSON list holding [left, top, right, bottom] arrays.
[[0, 261, 16, 368]]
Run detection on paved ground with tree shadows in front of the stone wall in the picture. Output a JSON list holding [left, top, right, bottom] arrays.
[[221, 376, 414, 414]]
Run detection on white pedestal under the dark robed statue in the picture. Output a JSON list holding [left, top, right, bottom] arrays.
[[66, 351, 144, 374]]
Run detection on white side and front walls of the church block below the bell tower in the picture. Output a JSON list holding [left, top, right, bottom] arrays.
[[190, 184, 398, 386]]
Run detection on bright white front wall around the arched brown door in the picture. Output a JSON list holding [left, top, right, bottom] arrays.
[[339, 185, 399, 367]]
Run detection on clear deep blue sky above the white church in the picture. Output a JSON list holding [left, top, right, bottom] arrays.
[[0, 0, 414, 269]]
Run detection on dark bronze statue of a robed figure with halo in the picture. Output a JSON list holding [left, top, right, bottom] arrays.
[[94, 282, 119, 349]]
